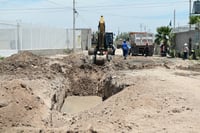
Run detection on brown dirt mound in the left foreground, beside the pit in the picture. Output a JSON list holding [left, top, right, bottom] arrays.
[[0, 80, 49, 127]]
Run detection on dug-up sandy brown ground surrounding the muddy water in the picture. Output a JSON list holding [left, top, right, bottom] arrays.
[[0, 51, 200, 133]]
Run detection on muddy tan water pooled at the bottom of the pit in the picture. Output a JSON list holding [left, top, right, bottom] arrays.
[[61, 96, 102, 114]]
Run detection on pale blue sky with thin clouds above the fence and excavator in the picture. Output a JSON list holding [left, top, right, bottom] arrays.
[[0, 0, 192, 34]]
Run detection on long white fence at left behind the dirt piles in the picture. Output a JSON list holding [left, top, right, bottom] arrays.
[[0, 23, 91, 56]]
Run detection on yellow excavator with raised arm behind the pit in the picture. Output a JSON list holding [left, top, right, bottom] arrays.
[[88, 16, 114, 65]]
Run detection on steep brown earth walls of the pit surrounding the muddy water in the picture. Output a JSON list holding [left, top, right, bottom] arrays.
[[51, 67, 125, 111]]
